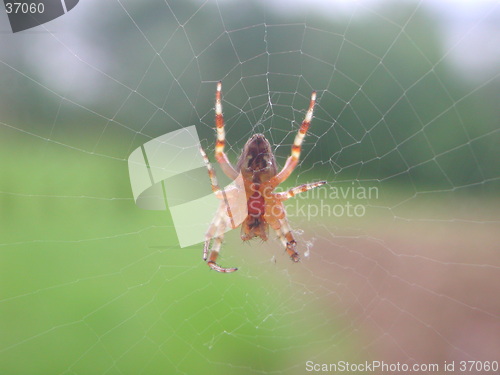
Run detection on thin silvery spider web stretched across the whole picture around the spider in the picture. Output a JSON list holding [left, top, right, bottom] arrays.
[[0, 0, 500, 374]]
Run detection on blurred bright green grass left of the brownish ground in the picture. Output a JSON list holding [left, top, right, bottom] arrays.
[[0, 136, 362, 374]]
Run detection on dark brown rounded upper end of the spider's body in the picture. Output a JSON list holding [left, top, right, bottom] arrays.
[[237, 134, 277, 182]]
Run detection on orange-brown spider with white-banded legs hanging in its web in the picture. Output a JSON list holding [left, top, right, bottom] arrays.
[[200, 82, 326, 272]]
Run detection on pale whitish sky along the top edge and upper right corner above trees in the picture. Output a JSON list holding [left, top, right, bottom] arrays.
[[260, 0, 500, 81]]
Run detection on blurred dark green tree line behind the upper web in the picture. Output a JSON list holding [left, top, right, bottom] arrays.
[[0, 1, 500, 190]]
